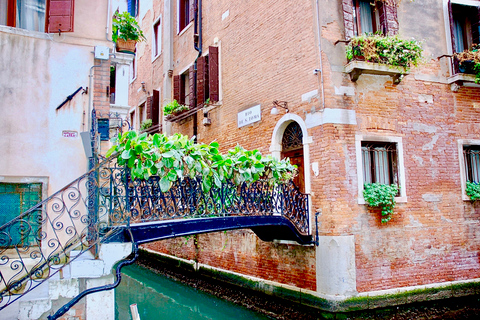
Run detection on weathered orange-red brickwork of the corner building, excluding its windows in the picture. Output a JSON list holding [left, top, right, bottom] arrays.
[[130, 0, 480, 298]]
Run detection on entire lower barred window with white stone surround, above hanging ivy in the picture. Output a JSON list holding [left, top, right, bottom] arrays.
[[355, 135, 407, 204]]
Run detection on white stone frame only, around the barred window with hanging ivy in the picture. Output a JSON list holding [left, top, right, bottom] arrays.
[[355, 134, 407, 204]]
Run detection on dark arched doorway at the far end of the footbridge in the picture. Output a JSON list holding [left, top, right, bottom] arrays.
[[281, 121, 305, 192]]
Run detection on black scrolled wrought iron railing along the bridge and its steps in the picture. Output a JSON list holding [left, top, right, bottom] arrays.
[[0, 159, 309, 310]]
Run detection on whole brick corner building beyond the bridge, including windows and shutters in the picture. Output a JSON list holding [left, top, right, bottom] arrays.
[[129, 0, 480, 306]]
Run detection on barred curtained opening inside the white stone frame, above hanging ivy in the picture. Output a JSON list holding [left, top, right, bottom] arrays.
[[362, 141, 398, 185]]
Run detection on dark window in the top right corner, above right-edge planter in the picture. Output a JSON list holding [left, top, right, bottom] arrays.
[[448, 0, 480, 52]]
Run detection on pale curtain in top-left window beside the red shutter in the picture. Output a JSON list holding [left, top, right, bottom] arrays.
[[16, 0, 46, 32]]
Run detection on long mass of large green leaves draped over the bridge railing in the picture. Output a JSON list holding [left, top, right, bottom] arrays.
[[106, 131, 296, 192]]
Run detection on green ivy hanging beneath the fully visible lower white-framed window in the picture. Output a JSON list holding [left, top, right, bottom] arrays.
[[363, 183, 398, 223]]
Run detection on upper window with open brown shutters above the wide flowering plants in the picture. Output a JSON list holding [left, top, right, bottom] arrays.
[[342, 0, 398, 39]]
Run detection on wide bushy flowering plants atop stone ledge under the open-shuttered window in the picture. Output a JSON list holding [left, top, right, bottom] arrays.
[[346, 34, 422, 68]]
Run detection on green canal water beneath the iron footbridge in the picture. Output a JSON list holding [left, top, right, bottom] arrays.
[[115, 264, 270, 320]]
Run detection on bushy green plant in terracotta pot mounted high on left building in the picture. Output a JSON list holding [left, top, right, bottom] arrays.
[[112, 12, 145, 53]]
